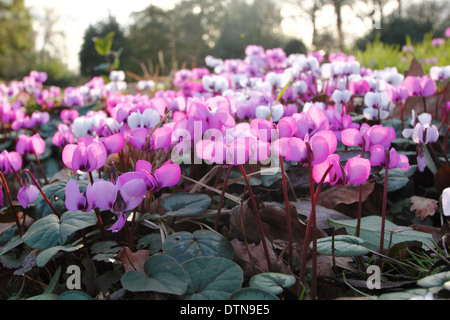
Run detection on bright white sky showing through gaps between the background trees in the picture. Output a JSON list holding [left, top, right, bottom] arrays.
[[25, 0, 392, 72]]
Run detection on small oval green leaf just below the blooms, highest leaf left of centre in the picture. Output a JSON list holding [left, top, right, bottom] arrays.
[[161, 192, 211, 217]]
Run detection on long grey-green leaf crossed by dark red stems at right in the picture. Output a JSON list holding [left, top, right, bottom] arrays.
[[329, 216, 434, 250]]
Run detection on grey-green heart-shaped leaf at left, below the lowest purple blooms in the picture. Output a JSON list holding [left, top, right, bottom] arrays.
[[22, 211, 97, 250]]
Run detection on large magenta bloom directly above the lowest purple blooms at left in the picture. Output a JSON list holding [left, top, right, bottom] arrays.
[[62, 137, 107, 172]]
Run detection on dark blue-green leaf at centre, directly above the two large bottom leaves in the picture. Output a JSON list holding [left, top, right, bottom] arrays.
[[163, 230, 234, 263]]
